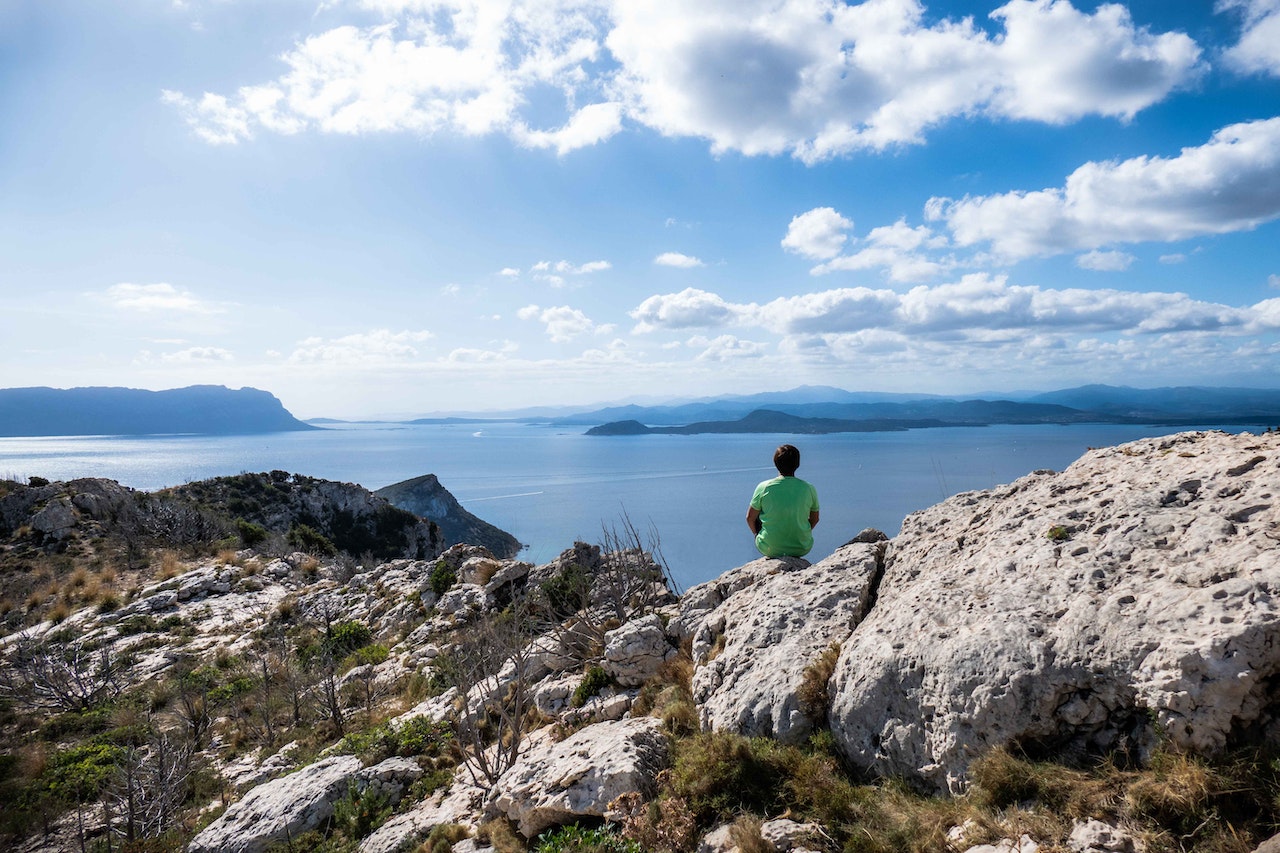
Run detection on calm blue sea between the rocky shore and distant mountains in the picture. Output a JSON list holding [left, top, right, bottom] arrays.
[[0, 424, 1259, 587]]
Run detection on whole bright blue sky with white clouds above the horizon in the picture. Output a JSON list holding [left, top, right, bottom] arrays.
[[0, 0, 1280, 418]]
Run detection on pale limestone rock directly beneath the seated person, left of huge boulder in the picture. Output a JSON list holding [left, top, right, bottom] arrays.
[[682, 543, 879, 743]]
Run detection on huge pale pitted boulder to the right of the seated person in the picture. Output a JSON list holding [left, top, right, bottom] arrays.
[[831, 433, 1280, 792]]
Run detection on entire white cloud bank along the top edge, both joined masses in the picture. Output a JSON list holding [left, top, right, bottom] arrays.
[[163, 0, 1198, 163]]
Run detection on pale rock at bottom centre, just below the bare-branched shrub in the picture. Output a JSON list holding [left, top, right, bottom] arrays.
[[489, 717, 668, 838]]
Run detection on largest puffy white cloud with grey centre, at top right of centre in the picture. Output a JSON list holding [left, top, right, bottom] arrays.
[[605, 0, 1199, 161]]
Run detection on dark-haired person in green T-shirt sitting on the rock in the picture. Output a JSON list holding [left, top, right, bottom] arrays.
[[746, 444, 818, 557]]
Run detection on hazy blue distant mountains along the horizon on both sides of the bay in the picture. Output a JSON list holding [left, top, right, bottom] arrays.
[[0, 386, 1280, 437]]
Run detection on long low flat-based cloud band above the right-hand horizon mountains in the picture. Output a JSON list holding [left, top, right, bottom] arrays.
[[631, 273, 1280, 346]]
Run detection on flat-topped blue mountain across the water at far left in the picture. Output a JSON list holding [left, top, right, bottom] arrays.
[[0, 386, 315, 437]]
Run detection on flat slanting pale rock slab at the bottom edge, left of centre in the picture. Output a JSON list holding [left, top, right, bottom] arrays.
[[187, 756, 360, 853]]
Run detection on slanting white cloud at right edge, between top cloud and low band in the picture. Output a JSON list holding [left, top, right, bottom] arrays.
[[925, 118, 1280, 260]]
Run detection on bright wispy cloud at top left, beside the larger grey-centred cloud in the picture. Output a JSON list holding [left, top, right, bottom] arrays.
[[164, 0, 622, 154]]
